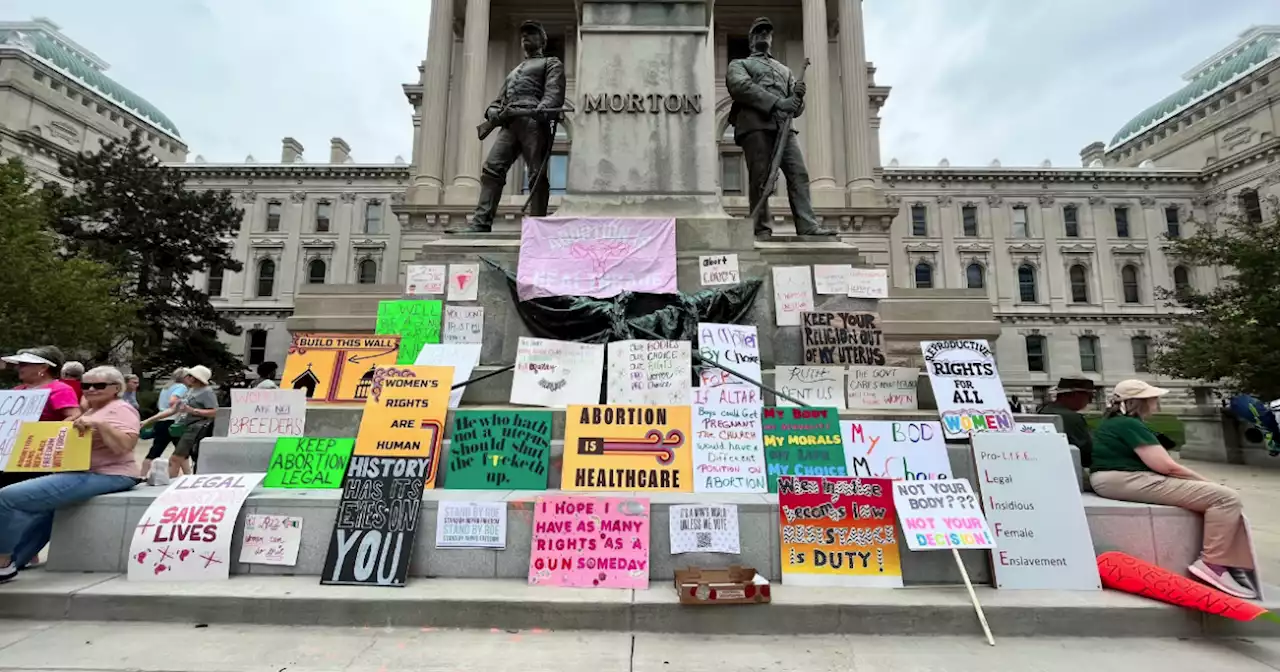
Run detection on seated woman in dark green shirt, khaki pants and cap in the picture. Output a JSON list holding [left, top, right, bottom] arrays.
[[1089, 380, 1257, 599]]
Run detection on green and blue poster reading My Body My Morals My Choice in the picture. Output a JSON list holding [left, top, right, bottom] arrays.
[[764, 406, 845, 493]]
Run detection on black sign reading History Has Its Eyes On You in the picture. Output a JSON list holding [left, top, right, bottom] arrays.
[[320, 453, 435, 586]]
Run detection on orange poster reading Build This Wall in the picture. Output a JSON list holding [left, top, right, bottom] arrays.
[[280, 332, 399, 403]]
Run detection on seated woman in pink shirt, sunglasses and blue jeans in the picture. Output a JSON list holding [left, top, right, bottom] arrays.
[[0, 366, 138, 584]]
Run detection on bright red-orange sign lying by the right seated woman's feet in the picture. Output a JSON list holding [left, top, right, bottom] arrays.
[[1098, 550, 1277, 621]]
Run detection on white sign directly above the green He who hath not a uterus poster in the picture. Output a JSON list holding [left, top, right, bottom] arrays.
[[511, 337, 604, 408]]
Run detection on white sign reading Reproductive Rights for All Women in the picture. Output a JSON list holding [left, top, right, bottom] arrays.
[[920, 340, 1014, 439]]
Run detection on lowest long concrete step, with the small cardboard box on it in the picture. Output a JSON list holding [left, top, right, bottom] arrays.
[[0, 570, 1280, 639]]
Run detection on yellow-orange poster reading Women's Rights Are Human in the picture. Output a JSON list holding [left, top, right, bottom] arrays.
[[352, 366, 453, 478]]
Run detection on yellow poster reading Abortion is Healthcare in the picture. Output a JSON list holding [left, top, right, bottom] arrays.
[[561, 404, 694, 493]]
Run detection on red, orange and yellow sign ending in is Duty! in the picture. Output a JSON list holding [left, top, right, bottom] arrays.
[[778, 476, 902, 588]]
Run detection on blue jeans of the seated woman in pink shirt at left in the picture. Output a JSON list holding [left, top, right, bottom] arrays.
[[0, 471, 138, 568]]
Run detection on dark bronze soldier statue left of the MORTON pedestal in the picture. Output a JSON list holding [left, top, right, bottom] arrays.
[[448, 20, 564, 233]]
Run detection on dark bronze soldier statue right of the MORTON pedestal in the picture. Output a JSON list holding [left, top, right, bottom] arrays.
[[724, 18, 836, 237]]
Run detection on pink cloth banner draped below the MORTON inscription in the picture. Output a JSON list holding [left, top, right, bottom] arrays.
[[516, 218, 676, 301]]
